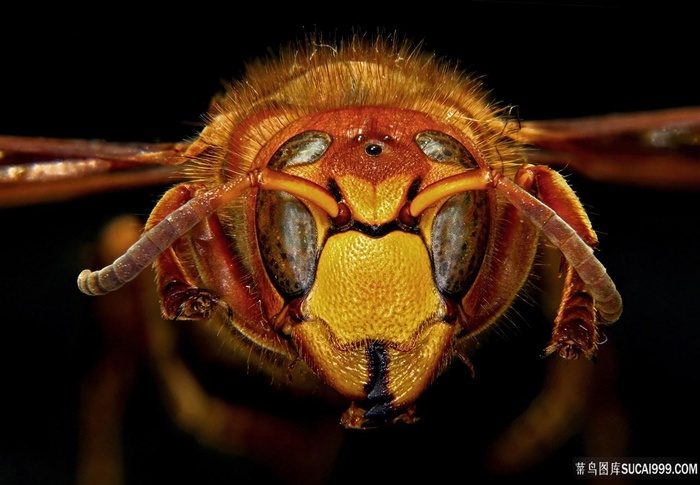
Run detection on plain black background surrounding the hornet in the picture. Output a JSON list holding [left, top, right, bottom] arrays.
[[0, 2, 700, 484]]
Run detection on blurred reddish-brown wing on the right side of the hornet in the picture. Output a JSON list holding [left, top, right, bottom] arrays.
[[508, 107, 700, 189]]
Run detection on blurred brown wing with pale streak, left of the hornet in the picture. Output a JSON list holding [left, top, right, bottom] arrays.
[[0, 136, 189, 207]]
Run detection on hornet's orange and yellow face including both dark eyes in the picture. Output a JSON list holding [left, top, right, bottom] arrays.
[[243, 107, 490, 424]]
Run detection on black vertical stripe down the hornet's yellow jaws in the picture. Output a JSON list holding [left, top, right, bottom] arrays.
[[363, 342, 400, 428]]
